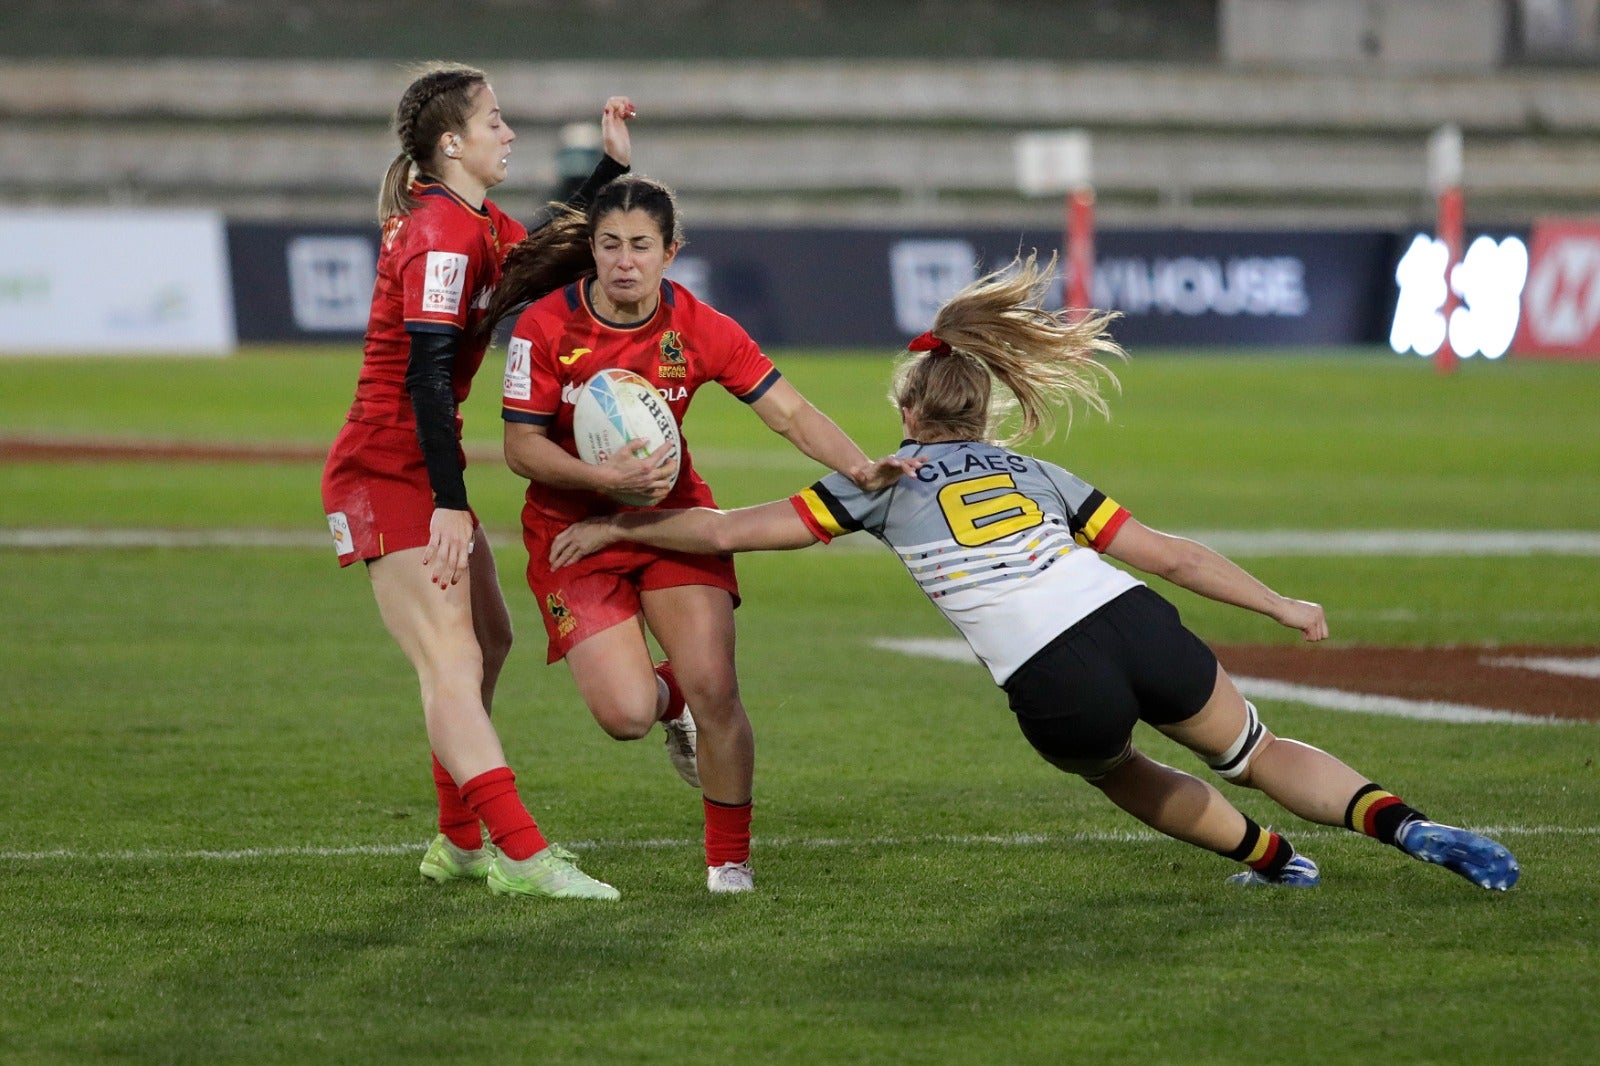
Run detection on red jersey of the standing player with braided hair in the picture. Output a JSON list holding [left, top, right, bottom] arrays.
[[349, 179, 528, 435]]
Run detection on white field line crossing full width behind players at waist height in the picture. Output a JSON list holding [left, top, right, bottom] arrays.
[[0, 527, 1600, 557]]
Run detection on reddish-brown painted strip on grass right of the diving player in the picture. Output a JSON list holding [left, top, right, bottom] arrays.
[[1216, 643, 1600, 722]]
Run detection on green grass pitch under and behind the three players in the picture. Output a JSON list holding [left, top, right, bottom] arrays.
[[0, 347, 1600, 1063]]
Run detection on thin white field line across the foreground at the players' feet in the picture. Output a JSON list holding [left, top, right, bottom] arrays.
[[0, 826, 1600, 863]]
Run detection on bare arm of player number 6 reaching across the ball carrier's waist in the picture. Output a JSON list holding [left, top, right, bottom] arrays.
[[550, 499, 818, 570]]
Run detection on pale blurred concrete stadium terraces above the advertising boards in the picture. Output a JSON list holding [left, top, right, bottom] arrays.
[[0, 0, 1600, 226]]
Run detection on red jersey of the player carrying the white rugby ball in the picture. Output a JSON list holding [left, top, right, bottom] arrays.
[[502, 279, 781, 525]]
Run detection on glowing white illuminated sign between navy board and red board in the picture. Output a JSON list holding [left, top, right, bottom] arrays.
[[1389, 234, 1528, 359]]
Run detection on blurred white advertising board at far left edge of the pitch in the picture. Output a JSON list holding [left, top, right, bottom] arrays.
[[0, 210, 237, 355]]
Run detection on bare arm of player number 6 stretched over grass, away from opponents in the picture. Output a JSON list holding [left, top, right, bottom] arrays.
[[1106, 519, 1328, 640]]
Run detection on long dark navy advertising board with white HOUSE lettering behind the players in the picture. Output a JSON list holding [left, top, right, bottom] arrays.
[[227, 222, 1400, 347]]
